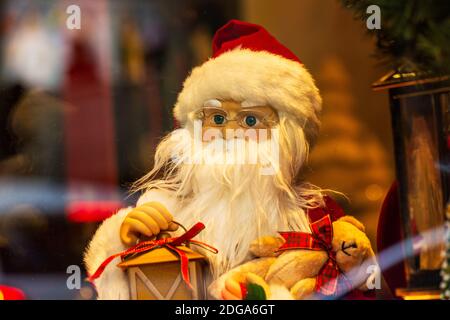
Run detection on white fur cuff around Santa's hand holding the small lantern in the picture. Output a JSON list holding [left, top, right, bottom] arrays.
[[84, 190, 175, 300]]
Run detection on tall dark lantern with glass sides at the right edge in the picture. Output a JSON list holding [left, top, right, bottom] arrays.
[[373, 72, 450, 299]]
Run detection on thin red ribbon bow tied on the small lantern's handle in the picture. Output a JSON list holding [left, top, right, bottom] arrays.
[[88, 222, 218, 289]]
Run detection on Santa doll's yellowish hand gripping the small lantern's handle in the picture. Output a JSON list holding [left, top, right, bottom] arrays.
[[120, 202, 178, 246]]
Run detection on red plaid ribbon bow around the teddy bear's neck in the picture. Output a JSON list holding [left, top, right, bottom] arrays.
[[275, 215, 352, 296]]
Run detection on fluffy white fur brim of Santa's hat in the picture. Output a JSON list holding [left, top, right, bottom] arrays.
[[174, 48, 322, 141]]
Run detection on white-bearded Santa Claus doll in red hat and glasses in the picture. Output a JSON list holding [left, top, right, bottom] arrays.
[[85, 20, 376, 299]]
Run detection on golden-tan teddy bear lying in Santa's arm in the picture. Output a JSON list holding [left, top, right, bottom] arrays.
[[209, 216, 378, 300]]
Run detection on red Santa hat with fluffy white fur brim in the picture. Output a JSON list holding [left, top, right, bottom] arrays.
[[174, 20, 322, 143]]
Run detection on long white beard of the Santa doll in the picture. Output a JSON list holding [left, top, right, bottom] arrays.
[[138, 129, 320, 279]]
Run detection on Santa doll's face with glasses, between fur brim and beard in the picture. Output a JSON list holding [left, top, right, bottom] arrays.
[[198, 99, 278, 139]]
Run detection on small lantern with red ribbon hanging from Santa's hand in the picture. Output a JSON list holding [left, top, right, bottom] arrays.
[[88, 221, 218, 300]]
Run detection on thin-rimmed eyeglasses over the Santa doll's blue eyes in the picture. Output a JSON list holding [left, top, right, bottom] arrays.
[[197, 107, 278, 129]]
